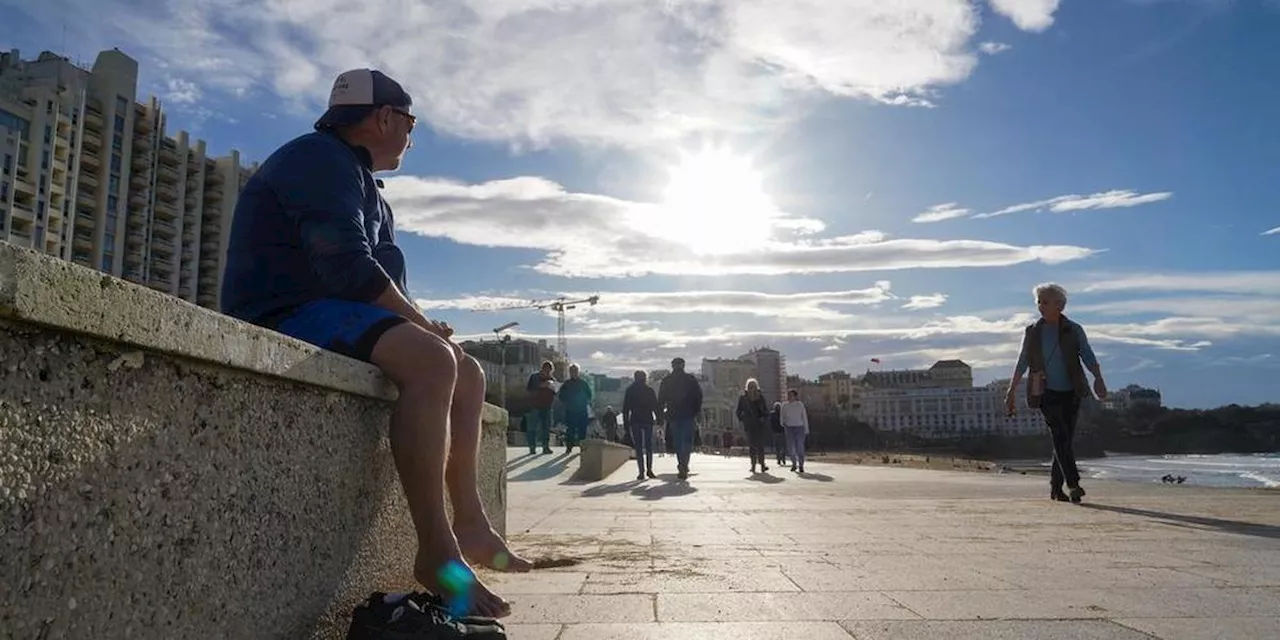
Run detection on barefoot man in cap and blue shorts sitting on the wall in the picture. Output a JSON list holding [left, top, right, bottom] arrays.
[[221, 69, 531, 617]]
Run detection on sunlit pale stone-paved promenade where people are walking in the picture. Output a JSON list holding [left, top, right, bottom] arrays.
[[486, 449, 1280, 640]]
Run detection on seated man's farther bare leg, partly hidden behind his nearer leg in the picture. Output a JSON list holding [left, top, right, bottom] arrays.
[[445, 349, 534, 572]]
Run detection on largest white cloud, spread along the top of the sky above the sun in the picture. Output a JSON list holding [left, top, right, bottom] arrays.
[[0, 0, 1057, 145]]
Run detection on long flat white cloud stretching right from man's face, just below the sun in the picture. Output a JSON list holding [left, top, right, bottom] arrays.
[[385, 177, 1094, 278]]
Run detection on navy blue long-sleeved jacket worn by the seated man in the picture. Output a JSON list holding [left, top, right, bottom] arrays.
[[221, 132, 408, 326]]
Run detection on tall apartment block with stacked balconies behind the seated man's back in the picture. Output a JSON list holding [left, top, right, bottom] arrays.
[[0, 50, 255, 308]]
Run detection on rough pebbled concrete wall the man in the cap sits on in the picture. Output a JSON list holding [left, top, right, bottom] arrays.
[[0, 243, 506, 639]]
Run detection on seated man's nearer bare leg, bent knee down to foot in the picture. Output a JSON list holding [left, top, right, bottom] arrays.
[[371, 324, 511, 617]]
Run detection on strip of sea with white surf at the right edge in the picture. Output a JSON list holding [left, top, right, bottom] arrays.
[[1076, 453, 1280, 489]]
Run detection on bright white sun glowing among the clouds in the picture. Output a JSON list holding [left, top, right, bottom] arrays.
[[655, 148, 777, 255]]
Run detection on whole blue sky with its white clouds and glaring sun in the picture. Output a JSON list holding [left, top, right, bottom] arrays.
[[0, 0, 1280, 407]]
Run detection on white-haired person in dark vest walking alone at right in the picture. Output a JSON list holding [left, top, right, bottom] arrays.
[[1005, 283, 1107, 503]]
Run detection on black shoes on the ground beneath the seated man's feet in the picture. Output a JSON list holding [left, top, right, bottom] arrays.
[[347, 593, 507, 640]]
